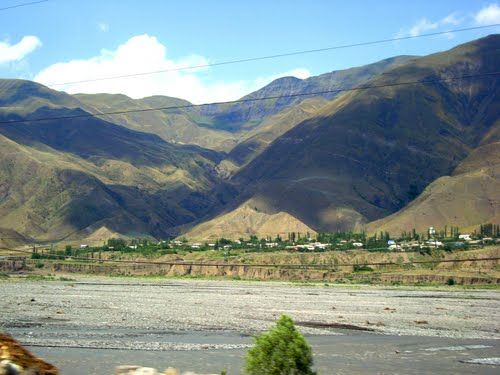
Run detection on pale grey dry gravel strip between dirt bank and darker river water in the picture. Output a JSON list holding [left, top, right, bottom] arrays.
[[0, 278, 500, 339]]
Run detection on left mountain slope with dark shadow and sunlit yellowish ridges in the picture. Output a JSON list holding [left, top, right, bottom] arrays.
[[0, 84, 234, 240]]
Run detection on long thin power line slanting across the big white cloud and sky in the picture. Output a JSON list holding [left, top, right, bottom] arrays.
[[47, 23, 500, 86]]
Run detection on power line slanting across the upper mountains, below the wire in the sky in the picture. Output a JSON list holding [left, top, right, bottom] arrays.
[[0, 71, 500, 125]]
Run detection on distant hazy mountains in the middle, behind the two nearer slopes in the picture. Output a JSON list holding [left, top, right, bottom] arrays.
[[74, 56, 412, 156]]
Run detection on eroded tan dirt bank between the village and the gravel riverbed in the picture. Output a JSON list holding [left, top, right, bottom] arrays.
[[0, 247, 500, 285]]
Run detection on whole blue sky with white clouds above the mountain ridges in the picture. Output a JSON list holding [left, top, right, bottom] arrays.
[[0, 0, 500, 103]]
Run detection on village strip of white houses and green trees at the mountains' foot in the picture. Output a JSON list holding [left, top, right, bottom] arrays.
[[23, 223, 500, 259]]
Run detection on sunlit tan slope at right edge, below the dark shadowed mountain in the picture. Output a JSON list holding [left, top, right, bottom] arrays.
[[364, 138, 500, 234]]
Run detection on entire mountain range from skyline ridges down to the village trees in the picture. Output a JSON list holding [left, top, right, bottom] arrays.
[[0, 35, 500, 241]]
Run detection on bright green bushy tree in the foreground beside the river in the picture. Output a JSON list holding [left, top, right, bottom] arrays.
[[246, 315, 315, 375]]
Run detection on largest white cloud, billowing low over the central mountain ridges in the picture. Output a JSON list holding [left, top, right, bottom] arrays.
[[35, 34, 310, 104]]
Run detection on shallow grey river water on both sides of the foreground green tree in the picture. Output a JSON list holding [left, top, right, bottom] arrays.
[[17, 331, 500, 375]]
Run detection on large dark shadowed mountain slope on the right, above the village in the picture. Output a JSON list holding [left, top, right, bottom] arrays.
[[232, 35, 500, 230]]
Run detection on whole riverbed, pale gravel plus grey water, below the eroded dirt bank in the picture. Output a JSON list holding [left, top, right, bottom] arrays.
[[0, 276, 500, 374]]
